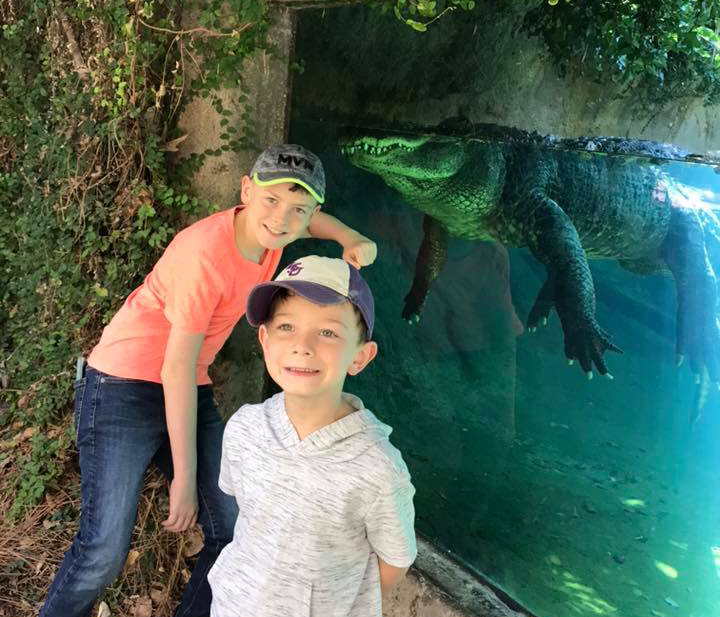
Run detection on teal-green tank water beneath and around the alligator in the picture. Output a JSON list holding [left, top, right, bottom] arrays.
[[286, 117, 720, 617]]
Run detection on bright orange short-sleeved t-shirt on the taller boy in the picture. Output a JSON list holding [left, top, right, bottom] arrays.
[[88, 208, 282, 385]]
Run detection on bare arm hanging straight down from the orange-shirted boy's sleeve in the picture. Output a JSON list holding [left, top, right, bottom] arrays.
[[160, 326, 205, 531]]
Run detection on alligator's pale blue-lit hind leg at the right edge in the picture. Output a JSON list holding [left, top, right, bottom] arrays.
[[662, 208, 720, 382]]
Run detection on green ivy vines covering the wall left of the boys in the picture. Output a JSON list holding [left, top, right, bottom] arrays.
[[0, 0, 268, 516]]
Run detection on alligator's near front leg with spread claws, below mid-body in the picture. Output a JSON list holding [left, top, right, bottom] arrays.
[[523, 190, 622, 377]]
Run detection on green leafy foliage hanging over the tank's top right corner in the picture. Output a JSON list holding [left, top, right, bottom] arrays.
[[523, 0, 720, 104]]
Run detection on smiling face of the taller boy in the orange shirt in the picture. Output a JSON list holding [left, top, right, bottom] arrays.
[[241, 176, 319, 250]]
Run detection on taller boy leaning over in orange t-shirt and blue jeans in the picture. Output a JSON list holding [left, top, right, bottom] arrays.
[[40, 145, 377, 617]]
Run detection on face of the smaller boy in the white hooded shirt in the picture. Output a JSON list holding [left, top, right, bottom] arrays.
[[258, 295, 377, 400]]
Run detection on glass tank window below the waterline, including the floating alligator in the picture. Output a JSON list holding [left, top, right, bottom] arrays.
[[278, 9, 720, 617]]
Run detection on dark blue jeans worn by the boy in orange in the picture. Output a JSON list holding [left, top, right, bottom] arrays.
[[40, 367, 238, 617]]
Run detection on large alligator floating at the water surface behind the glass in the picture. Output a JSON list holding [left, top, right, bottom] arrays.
[[340, 129, 720, 406]]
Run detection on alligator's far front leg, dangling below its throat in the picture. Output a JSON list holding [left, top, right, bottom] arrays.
[[402, 214, 447, 323]]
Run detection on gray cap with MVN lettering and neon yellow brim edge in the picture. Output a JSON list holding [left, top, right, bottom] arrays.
[[250, 144, 325, 203]]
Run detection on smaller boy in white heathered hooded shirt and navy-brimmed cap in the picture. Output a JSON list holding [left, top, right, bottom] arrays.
[[208, 256, 417, 617]]
